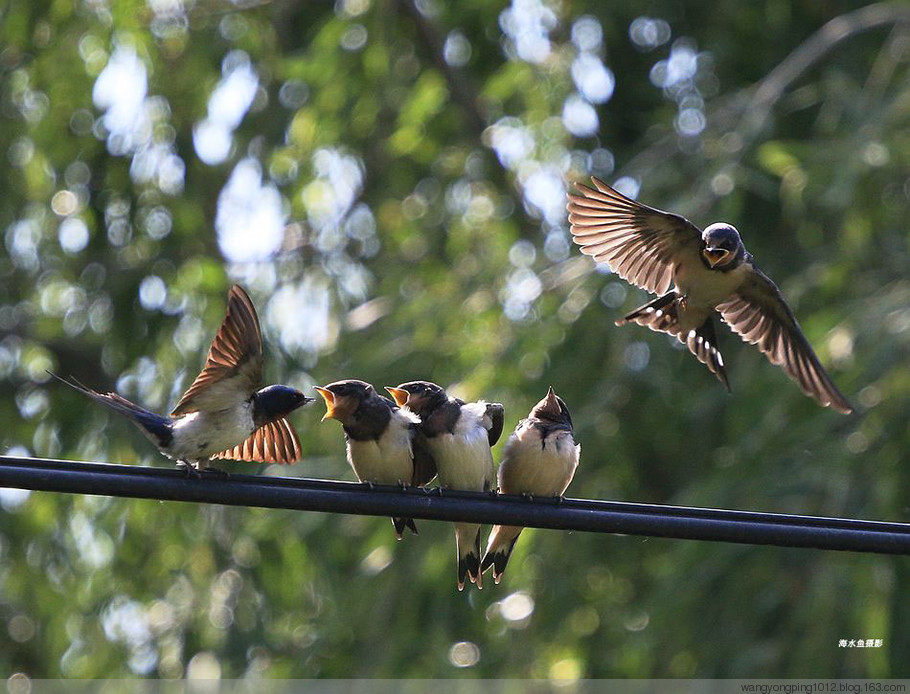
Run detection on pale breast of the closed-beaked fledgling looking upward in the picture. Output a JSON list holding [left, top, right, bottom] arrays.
[[499, 424, 581, 496]]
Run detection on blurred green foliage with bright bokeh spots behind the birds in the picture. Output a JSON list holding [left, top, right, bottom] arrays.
[[0, 0, 910, 679]]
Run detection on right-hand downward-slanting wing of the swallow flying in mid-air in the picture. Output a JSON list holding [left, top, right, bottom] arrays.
[[717, 265, 853, 414]]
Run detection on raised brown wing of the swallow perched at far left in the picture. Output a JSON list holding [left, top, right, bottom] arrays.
[[171, 284, 263, 417]]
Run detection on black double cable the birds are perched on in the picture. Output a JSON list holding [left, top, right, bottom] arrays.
[[0, 456, 910, 555]]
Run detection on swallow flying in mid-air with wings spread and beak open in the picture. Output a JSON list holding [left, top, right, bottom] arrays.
[[568, 178, 853, 414]]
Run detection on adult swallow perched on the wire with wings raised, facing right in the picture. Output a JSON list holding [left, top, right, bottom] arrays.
[[51, 284, 313, 473]]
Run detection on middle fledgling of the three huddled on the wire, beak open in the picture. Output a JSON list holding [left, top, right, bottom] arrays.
[[388, 381, 504, 590]]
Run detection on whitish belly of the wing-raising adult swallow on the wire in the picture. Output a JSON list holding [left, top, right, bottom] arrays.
[[165, 401, 256, 461]]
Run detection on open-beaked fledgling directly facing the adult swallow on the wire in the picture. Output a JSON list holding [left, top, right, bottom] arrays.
[[316, 379, 436, 540]]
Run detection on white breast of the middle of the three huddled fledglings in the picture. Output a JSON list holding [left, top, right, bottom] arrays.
[[427, 403, 493, 492]]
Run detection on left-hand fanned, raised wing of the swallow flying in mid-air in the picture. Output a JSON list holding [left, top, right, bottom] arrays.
[[568, 177, 703, 294]]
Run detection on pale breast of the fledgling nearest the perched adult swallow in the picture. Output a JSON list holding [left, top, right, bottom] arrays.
[[347, 408, 420, 484]]
